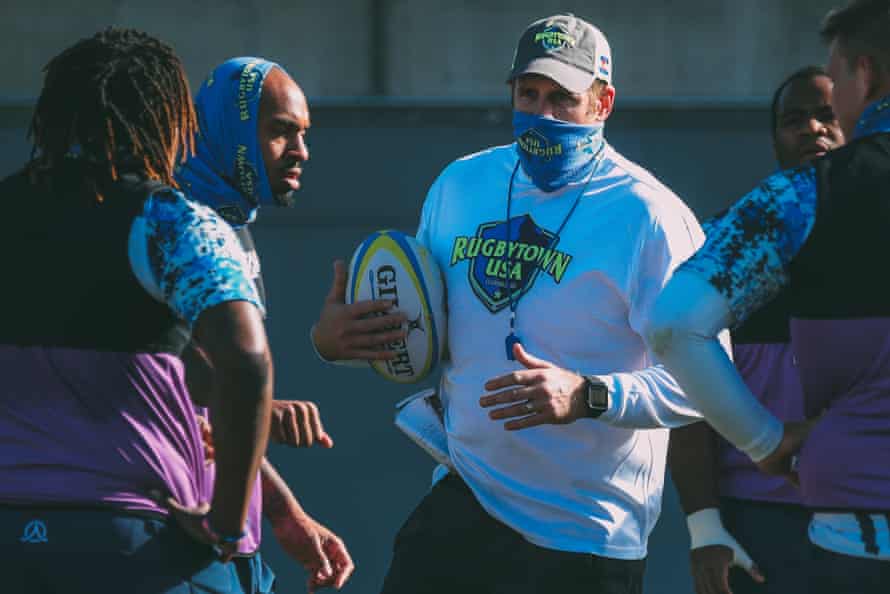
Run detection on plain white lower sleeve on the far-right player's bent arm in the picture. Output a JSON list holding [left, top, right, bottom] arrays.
[[646, 273, 783, 461]]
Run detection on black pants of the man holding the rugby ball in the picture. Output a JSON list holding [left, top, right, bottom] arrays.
[[383, 474, 646, 594]]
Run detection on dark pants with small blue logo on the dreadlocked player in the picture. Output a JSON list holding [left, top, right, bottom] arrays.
[[0, 506, 245, 594]]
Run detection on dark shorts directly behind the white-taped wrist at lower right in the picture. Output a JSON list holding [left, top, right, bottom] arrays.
[[720, 498, 813, 594]]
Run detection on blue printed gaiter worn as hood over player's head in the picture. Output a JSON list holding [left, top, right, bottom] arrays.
[[177, 57, 284, 227]]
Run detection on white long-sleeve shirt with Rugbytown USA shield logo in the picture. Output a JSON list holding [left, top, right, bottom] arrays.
[[417, 145, 703, 559]]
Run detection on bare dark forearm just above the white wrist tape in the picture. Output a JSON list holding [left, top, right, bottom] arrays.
[[668, 422, 719, 515]]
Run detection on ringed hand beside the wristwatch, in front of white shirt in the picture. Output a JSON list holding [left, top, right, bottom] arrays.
[[479, 343, 587, 431]]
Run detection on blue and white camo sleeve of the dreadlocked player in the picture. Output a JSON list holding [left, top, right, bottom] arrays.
[[143, 191, 263, 324]]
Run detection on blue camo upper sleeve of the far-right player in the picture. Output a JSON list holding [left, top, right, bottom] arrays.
[[678, 166, 817, 324]]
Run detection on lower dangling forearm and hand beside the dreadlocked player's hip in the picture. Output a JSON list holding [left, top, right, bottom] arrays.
[[260, 460, 355, 592]]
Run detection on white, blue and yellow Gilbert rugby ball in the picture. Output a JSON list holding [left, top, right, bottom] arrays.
[[346, 229, 447, 384]]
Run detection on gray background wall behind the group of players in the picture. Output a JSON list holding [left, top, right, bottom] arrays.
[[0, 0, 834, 594]]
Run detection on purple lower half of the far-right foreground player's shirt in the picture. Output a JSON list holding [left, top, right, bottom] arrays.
[[791, 318, 890, 510]]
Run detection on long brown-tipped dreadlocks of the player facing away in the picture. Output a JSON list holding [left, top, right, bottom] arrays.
[[28, 28, 197, 200]]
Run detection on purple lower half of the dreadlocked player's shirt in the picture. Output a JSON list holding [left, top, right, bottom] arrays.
[[0, 345, 208, 514]]
